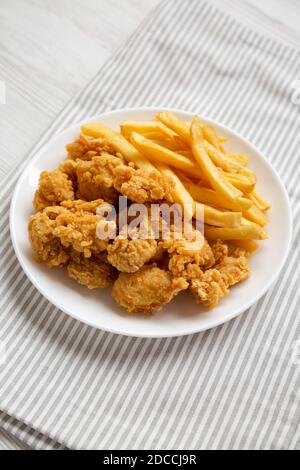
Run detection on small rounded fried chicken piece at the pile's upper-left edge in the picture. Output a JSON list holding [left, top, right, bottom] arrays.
[[33, 168, 74, 211]]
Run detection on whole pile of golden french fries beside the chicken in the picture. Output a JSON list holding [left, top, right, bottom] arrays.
[[81, 111, 270, 252]]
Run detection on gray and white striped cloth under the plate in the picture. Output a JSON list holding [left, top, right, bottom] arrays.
[[0, 0, 300, 449]]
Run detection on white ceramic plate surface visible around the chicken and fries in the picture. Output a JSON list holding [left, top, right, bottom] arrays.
[[10, 108, 292, 337]]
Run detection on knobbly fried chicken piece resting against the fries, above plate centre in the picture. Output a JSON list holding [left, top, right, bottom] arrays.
[[114, 165, 174, 204]]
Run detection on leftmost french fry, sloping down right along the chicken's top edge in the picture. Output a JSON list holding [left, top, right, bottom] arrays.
[[81, 122, 157, 173]]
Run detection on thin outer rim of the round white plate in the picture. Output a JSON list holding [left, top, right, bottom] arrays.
[[9, 106, 293, 339]]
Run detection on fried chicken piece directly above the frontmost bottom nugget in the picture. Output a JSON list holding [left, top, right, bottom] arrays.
[[107, 237, 157, 273]]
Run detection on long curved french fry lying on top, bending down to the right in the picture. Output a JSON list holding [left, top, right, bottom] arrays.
[[191, 116, 242, 201]]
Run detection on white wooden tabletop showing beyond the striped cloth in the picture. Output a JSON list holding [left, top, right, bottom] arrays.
[[0, 0, 300, 177]]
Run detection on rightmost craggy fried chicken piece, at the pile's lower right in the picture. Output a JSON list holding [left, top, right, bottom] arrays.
[[190, 256, 250, 308]]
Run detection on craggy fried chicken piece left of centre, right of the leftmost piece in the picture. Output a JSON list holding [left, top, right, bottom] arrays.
[[54, 199, 108, 258]]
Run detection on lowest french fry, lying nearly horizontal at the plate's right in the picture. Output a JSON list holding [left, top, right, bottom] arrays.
[[204, 222, 268, 240]]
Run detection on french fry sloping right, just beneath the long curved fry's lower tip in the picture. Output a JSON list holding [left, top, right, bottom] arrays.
[[180, 174, 252, 212]]
